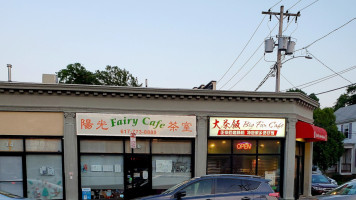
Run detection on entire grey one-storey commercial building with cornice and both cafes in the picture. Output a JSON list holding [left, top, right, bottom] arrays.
[[0, 82, 326, 199]]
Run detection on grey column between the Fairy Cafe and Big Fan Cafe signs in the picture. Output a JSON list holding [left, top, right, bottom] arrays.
[[194, 116, 208, 176]]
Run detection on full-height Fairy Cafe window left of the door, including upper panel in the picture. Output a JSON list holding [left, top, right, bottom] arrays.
[[80, 139, 124, 199]]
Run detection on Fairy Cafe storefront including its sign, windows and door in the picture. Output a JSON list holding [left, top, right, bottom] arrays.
[[76, 113, 196, 199]]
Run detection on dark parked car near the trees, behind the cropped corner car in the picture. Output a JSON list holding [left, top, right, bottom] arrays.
[[312, 174, 337, 195]]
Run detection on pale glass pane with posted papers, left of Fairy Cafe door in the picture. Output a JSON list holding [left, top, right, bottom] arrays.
[[80, 155, 124, 191]]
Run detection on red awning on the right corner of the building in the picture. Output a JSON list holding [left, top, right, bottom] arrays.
[[296, 121, 328, 142]]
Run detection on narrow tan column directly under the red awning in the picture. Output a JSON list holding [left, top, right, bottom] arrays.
[[303, 142, 313, 196]]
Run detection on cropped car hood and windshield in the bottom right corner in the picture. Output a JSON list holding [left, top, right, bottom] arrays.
[[307, 179, 356, 200]]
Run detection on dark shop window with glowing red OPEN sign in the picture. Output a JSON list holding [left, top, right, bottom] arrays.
[[207, 139, 282, 192]]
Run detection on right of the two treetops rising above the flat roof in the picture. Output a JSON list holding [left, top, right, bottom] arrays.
[[95, 65, 142, 87]]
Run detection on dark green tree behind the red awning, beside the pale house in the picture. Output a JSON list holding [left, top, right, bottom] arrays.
[[313, 108, 345, 171]]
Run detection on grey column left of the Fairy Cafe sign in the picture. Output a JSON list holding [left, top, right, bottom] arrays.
[[63, 113, 79, 200]]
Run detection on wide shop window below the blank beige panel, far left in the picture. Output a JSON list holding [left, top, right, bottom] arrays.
[[0, 137, 64, 199]]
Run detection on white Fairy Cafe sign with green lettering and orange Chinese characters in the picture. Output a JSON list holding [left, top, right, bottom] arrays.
[[76, 113, 196, 137]]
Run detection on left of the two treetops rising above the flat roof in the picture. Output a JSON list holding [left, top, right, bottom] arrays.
[[57, 63, 100, 85]]
